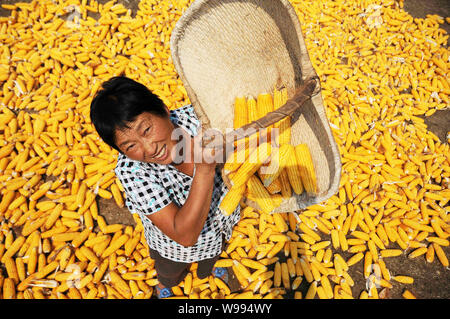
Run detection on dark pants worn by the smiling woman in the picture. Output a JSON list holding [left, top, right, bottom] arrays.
[[149, 239, 225, 288]]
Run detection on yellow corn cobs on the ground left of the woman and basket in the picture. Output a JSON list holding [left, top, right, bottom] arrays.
[[0, 0, 192, 298]]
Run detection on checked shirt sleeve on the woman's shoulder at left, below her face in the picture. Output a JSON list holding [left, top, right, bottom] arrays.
[[116, 164, 172, 215]]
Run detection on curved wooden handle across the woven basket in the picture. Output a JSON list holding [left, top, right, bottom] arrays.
[[203, 77, 319, 148]]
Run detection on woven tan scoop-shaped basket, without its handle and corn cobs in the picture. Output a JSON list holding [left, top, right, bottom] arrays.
[[170, 0, 341, 212]]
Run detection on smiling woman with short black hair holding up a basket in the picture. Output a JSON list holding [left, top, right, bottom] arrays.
[[91, 76, 240, 298]]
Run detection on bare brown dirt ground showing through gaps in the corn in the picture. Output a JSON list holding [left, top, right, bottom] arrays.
[[0, 0, 450, 299]]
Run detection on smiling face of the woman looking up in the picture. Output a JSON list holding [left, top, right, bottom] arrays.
[[116, 112, 177, 165]]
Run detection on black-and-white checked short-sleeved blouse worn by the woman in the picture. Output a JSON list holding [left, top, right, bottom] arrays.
[[115, 105, 240, 263]]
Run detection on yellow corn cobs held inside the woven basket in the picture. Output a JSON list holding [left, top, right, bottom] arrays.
[[220, 88, 317, 215]]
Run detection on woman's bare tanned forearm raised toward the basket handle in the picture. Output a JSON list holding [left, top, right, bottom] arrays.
[[173, 170, 215, 246]]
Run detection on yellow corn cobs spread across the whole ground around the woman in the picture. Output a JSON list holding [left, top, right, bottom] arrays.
[[0, 0, 450, 298]]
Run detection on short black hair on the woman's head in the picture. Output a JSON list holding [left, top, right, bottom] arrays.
[[91, 76, 168, 152]]
